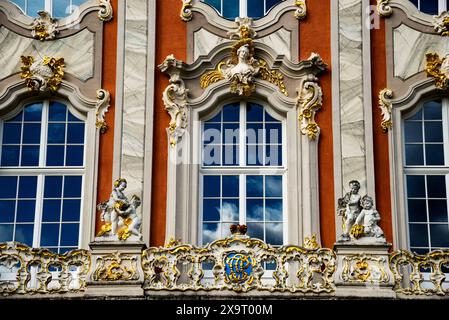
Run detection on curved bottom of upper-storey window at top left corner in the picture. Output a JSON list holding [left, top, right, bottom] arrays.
[[10, 0, 87, 18]]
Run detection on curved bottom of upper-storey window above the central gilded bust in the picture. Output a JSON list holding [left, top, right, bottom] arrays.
[[202, 0, 283, 20]]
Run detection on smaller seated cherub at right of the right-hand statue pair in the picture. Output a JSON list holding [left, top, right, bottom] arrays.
[[355, 195, 384, 238]]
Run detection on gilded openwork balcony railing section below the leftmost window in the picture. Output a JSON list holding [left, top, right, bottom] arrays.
[[0, 242, 91, 296]]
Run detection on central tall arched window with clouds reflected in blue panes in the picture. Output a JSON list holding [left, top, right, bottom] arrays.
[[199, 102, 286, 246]]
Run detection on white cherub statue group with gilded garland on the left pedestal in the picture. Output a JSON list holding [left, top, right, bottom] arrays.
[[97, 178, 142, 241]]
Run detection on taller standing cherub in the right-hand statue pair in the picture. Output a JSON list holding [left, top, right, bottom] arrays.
[[337, 180, 362, 241]]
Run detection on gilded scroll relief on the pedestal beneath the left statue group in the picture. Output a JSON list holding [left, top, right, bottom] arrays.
[[92, 252, 139, 281]]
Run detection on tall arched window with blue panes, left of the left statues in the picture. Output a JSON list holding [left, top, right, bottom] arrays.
[[0, 100, 85, 253]]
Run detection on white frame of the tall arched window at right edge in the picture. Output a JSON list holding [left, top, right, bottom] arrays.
[[401, 96, 449, 252]]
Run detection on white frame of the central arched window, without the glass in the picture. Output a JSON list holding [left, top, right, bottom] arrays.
[[197, 100, 288, 245]]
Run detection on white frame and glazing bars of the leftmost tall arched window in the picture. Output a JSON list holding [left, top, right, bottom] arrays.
[[0, 96, 91, 250]]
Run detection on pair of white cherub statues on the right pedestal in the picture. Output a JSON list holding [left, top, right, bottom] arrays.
[[337, 180, 386, 243]]
